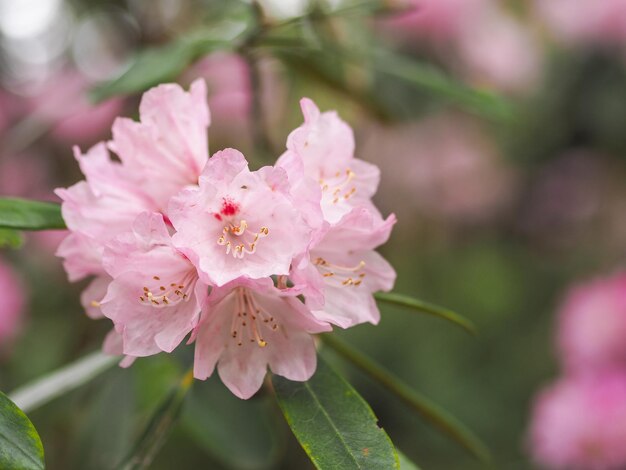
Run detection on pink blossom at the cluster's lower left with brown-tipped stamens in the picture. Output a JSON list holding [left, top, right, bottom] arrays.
[[100, 213, 207, 357]]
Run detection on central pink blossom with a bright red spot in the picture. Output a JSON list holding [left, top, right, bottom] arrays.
[[169, 149, 311, 286]]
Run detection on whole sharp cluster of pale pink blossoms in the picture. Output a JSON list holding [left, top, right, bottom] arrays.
[[57, 80, 395, 398]]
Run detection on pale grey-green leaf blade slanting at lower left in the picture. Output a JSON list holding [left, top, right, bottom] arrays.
[[10, 351, 120, 412]]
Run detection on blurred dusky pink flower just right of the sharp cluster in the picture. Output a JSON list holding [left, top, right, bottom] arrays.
[[363, 115, 516, 228]]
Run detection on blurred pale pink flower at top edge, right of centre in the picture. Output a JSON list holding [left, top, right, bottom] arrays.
[[380, 0, 542, 92]]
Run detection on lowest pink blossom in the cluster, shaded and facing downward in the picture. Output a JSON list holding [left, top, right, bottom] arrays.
[[194, 278, 330, 399]]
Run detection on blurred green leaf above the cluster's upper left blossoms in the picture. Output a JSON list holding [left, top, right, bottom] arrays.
[[90, 19, 249, 102]]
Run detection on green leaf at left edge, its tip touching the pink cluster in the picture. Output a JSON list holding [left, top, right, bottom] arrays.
[[0, 198, 65, 230]]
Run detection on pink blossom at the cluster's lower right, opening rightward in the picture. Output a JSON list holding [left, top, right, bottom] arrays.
[[292, 208, 396, 328]]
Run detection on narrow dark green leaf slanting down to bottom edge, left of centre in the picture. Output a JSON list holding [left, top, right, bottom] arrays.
[[116, 371, 193, 470]]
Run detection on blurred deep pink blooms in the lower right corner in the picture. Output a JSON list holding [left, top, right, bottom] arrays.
[[530, 274, 626, 470]]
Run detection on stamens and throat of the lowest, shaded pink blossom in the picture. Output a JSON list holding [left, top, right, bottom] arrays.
[[230, 287, 278, 348]]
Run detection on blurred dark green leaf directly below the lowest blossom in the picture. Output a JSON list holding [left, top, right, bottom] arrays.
[[181, 378, 287, 470]]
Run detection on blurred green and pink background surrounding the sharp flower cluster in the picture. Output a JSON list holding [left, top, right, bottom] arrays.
[[0, 0, 626, 470]]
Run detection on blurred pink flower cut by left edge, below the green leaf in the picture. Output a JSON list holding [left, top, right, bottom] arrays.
[[0, 257, 25, 352]]
